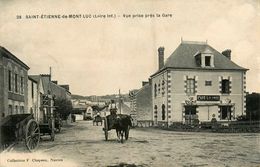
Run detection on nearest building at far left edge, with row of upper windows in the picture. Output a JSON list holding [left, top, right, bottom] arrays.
[[0, 46, 29, 119]]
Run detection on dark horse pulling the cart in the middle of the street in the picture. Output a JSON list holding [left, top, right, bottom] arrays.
[[114, 114, 133, 143]]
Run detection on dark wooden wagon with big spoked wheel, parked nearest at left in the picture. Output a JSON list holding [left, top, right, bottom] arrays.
[[1, 114, 40, 151]]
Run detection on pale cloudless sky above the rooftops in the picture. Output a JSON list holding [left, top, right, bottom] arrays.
[[0, 0, 260, 95]]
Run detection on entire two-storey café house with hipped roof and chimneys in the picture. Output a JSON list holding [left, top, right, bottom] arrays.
[[151, 41, 247, 124]]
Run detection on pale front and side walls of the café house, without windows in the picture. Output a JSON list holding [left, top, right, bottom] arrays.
[[152, 70, 246, 122]]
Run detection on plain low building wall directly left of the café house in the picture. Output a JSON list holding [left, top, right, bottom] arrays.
[[129, 82, 153, 126]]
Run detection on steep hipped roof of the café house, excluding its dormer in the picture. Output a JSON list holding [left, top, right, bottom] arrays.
[[152, 41, 248, 76]]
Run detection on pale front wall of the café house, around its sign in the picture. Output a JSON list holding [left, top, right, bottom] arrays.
[[171, 70, 244, 121]]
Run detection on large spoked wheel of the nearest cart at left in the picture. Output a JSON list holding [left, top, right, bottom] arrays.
[[25, 119, 40, 151]]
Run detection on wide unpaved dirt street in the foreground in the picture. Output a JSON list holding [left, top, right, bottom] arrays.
[[1, 121, 260, 167]]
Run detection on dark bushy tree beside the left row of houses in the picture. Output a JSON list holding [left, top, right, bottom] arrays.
[[54, 98, 72, 120]]
